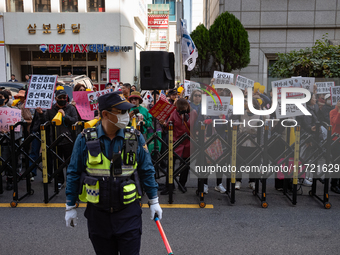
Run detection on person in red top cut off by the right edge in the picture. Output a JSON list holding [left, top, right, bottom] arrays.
[[329, 101, 340, 194]]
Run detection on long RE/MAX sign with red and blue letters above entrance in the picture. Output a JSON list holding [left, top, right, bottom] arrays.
[[39, 44, 132, 53]]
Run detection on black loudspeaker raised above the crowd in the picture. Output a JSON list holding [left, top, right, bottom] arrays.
[[140, 51, 175, 90]]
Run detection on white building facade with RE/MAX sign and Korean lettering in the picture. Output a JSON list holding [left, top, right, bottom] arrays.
[[0, 0, 183, 89]]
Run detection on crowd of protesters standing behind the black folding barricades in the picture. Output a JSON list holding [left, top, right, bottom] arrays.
[[0, 77, 340, 194]]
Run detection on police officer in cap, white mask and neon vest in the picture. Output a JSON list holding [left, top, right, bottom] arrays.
[[65, 91, 162, 255]]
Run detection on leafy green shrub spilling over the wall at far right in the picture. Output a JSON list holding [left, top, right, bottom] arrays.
[[269, 34, 340, 78]]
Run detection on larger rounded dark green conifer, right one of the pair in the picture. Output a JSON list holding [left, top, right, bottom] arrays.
[[209, 12, 250, 72]]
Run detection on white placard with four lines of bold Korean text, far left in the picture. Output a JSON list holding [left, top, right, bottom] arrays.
[[25, 74, 58, 109]]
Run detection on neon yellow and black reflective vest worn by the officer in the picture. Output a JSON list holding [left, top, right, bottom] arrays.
[[79, 126, 141, 211]]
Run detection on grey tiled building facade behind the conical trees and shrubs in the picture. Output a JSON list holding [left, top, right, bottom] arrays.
[[203, 0, 340, 87]]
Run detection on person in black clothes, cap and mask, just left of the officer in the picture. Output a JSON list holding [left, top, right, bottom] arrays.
[[36, 89, 78, 189]]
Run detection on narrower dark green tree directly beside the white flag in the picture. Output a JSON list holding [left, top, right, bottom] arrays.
[[190, 24, 211, 77]]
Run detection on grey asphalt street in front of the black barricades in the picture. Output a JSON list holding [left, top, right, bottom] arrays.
[[0, 175, 340, 255]]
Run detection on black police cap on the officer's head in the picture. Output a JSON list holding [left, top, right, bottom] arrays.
[[98, 91, 135, 111]]
